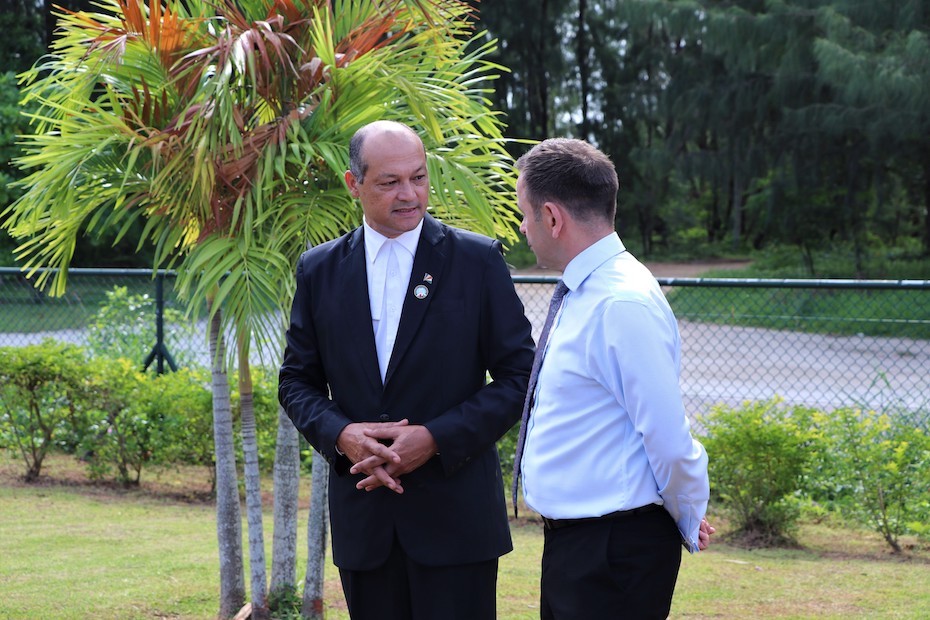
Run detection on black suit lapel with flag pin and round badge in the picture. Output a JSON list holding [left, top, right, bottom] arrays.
[[384, 214, 446, 385]]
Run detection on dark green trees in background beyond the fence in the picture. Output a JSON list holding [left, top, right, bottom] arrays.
[[0, 0, 930, 268]]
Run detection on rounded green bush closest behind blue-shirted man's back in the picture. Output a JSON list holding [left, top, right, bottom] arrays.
[[701, 399, 820, 546]]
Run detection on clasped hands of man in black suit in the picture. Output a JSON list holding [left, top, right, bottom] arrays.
[[336, 419, 437, 493]]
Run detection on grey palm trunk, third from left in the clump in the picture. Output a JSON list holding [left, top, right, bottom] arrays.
[[269, 406, 300, 599]]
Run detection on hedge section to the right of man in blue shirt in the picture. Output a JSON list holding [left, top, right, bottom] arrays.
[[702, 399, 930, 552]]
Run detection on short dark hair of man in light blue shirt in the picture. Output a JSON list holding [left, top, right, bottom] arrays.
[[517, 138, 620, 225]]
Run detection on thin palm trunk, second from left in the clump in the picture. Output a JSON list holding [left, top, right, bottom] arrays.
[[238, 342, 268, 620]]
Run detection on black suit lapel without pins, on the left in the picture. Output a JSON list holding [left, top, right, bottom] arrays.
[[333, 226, 382, 390]]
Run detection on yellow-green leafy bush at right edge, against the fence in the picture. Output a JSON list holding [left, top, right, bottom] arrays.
[[811, 408, 930, 552]]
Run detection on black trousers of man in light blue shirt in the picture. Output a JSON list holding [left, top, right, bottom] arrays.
[[540, 510, 681, 620]]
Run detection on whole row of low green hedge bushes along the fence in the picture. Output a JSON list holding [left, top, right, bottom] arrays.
[[0, 341, 930, 551]]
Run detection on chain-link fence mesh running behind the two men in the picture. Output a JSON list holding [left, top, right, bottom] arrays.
[[0, 268, 930, 417]]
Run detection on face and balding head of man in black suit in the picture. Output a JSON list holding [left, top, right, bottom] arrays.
[[346, 130, 429, 238]]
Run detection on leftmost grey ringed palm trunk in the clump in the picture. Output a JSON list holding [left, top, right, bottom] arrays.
[[210, 311, 245, 618]]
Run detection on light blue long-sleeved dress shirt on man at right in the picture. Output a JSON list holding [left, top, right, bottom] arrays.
[[522, 233, 710, 552]]
